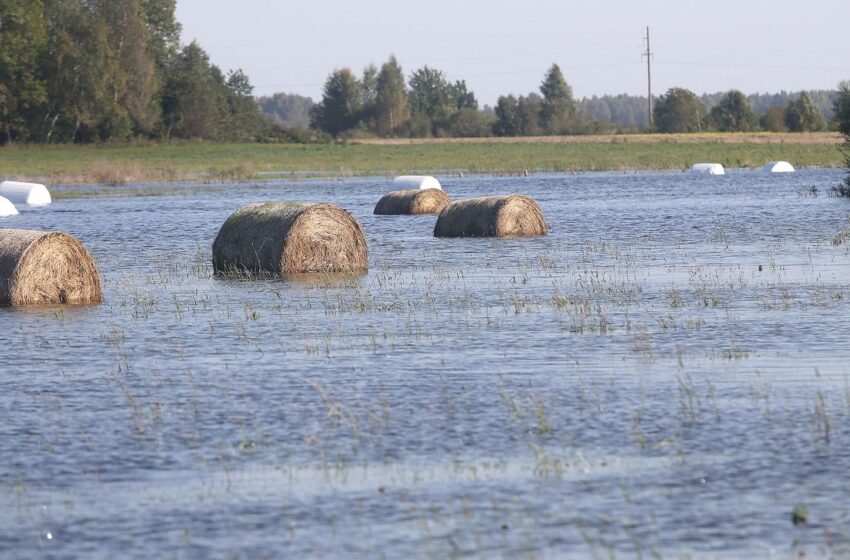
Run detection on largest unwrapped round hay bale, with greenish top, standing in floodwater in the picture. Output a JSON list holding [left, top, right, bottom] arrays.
[[213, 202, 369, 276]]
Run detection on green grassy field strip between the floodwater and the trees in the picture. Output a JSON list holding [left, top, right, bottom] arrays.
[[0, 133, 842, 184]]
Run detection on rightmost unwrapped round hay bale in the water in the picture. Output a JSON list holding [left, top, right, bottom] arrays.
[[434, 194, 548, 237]]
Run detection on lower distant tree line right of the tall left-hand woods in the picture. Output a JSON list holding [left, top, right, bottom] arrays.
[[284, 57, 837, 138]]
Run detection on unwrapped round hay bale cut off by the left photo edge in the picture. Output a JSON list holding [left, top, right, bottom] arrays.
[[0, 229, 103, 306]]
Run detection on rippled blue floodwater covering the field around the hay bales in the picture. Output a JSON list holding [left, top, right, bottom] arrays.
[[0, 170, 850, 558]]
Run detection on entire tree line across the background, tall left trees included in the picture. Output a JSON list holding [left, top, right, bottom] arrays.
[[0, 0, 838, 144]]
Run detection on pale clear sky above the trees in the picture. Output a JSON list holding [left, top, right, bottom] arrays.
[[177, 0, 850, 105]]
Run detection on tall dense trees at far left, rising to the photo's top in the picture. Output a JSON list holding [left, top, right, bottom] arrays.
[[0, 0, 267, 144]]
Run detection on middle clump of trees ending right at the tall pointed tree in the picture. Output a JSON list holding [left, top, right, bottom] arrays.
[[296, 56, 581, 138]]
